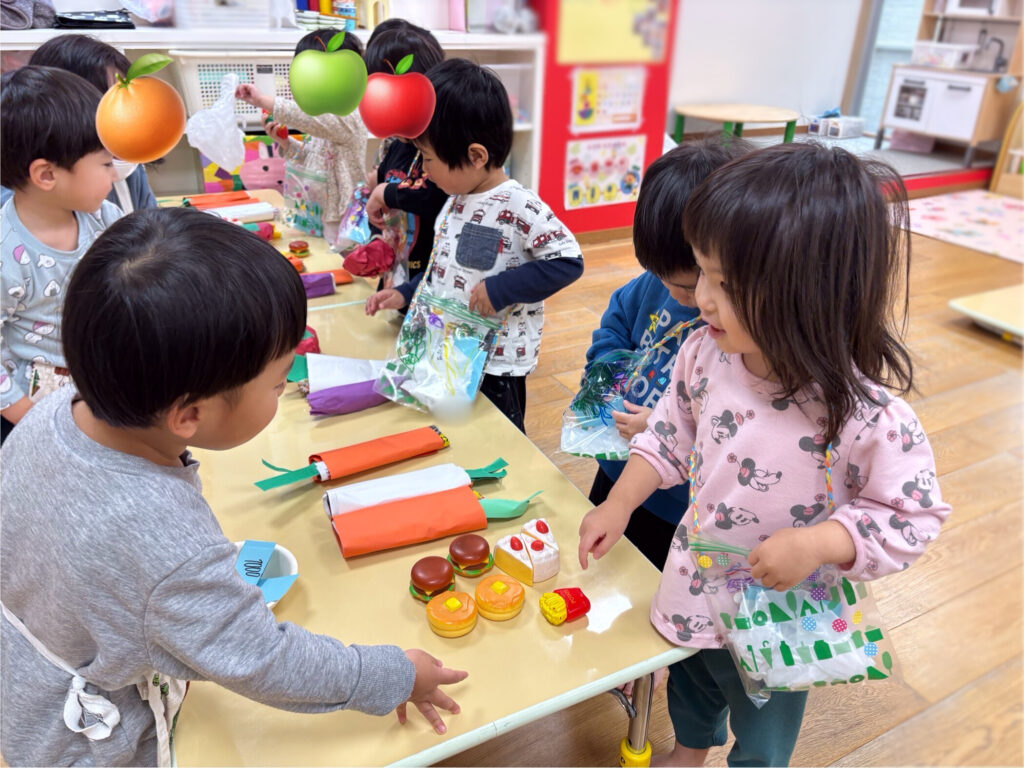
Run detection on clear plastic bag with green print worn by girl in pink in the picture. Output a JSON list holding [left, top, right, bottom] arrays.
[[690, 536, 898, 707]]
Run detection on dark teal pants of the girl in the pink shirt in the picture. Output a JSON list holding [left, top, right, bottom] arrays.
[[668, 648, 807, 766]]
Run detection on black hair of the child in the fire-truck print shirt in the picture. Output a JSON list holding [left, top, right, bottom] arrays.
[[419, 58, 512, 168]]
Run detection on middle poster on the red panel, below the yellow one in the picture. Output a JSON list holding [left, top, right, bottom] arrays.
[[569, 67, 647, 133]]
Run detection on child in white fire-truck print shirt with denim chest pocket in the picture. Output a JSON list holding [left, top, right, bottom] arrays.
[[367, 58, 583, 432]]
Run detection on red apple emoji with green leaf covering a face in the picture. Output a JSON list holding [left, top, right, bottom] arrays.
[[358, 53, 436, 138]]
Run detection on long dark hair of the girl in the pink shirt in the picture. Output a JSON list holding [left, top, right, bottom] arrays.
[[683, 142, 913, 442]]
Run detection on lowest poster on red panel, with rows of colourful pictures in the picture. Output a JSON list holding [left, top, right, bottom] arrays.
[[564, 133, 647, 211]]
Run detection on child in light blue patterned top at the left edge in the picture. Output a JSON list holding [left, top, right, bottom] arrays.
[[0, 67, 121, 436]]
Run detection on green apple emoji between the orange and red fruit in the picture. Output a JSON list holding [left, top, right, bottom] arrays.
[[288, 32, 367, 116]]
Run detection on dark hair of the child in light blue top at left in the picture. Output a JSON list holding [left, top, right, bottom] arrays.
[[0, 67, 103, 189]]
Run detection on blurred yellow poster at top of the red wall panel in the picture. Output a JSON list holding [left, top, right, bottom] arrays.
[[556, 0, 672, 65]]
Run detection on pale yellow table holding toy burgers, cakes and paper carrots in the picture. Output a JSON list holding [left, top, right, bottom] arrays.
[[161, 193, 692, 766]]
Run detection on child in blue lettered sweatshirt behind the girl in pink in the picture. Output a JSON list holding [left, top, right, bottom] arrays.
[[587, 136, 751, 568]]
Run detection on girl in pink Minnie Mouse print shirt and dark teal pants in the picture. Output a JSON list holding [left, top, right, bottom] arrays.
[[579, 143, 950, 765]]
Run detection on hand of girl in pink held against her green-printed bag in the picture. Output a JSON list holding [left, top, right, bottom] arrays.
[[746, 520, 857, 592]]
